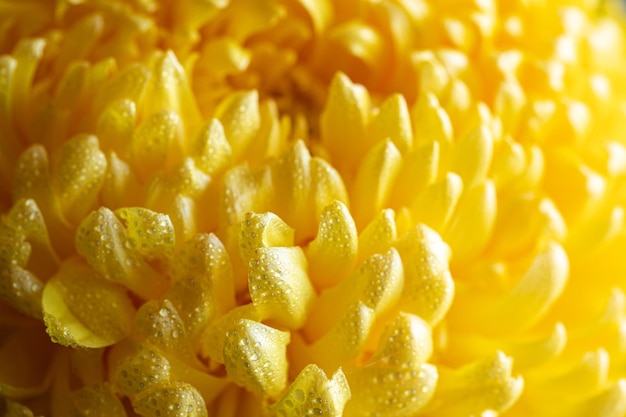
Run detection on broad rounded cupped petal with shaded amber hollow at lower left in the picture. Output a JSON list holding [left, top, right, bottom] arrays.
[[42, 261, 135, 348]]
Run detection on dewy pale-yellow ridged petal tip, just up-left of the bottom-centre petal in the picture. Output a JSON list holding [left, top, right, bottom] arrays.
[[224, 320, 290, 396]]
